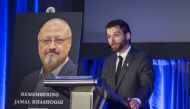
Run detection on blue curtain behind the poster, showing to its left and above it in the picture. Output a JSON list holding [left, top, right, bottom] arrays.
[[0, 0, 38, 109]]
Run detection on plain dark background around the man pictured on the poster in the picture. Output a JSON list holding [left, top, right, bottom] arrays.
[[6, 12, 82, 109]]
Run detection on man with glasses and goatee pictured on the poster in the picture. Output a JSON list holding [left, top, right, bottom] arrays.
[[20, 18, 77, 109]]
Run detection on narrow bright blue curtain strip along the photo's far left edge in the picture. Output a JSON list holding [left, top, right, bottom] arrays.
[[0, 0, 8, 109]]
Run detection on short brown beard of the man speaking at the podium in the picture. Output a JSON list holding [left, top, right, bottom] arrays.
[[111, 38, 127, 52]]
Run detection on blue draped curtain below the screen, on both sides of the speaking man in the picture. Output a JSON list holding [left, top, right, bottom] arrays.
[[80, 59, 190, 109]]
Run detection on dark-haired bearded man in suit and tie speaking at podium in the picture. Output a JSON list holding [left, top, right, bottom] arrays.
[[101, 19, 154, 109]]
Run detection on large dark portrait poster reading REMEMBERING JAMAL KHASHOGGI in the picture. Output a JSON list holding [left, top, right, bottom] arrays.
[[6, 12, 82, 109]]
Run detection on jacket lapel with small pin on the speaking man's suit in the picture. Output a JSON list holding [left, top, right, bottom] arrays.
[[116, 47, 134, 90]]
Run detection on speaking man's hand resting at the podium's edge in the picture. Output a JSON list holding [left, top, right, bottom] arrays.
[[127, 98, 140, 109]]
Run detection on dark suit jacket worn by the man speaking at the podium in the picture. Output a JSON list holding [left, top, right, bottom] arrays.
[[101, 47, 154, 108]]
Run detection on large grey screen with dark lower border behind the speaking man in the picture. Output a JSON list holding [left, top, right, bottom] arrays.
[[81, 0, 190, 58]]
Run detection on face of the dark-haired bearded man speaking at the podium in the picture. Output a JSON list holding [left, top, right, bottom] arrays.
[[106, 26, 129, 52]]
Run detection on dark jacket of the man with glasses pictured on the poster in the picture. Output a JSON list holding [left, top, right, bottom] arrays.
[[16, 60, 77, 109]]
